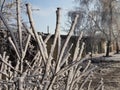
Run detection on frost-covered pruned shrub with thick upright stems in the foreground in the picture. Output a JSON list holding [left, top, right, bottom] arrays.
[[0, 0, 103, 90]]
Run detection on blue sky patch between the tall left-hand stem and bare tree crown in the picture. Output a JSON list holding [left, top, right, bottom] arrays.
[[24, 0, 74, 34]]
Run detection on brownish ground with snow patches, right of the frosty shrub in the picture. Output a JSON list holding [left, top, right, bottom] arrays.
[[92, 53, 120, 90]]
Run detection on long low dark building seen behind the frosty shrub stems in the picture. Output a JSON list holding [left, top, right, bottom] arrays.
[[43, 34, 116, 55]]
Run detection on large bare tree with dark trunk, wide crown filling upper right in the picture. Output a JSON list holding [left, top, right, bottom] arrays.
[[68, 0, 120, 56]]
